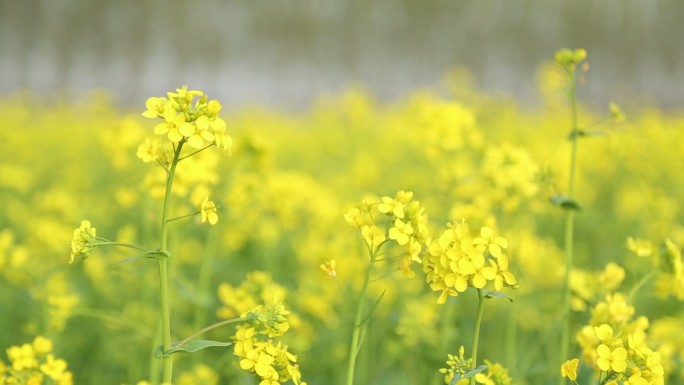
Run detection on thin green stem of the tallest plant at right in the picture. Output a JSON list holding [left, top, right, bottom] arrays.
[[558, 69, 579, 385]]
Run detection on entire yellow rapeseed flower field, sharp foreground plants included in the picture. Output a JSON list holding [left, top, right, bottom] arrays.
[[0, 50, 684, 385]]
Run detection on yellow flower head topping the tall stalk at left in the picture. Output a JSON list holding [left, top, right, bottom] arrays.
[[138, 86, 232, 164]]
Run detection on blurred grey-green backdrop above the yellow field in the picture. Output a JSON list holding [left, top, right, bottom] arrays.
[[0, 0, 684, 109]]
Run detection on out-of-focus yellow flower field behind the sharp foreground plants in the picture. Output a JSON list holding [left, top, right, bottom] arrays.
[[0, 63, 684, 385]]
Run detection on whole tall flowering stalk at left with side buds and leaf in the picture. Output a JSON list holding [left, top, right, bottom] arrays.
[[70, 87, 232, 384]]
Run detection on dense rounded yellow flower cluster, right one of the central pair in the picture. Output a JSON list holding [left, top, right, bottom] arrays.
[[423, 220, 518, 304]]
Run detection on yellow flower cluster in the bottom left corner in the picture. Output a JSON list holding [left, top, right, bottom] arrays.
[[0, 336, 73, 385]]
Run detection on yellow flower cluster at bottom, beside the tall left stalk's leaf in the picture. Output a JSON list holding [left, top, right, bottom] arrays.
[[233, 302, 306, 385]]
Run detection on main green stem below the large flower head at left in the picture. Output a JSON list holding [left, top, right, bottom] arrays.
[[159, 141, 184, 384]]
